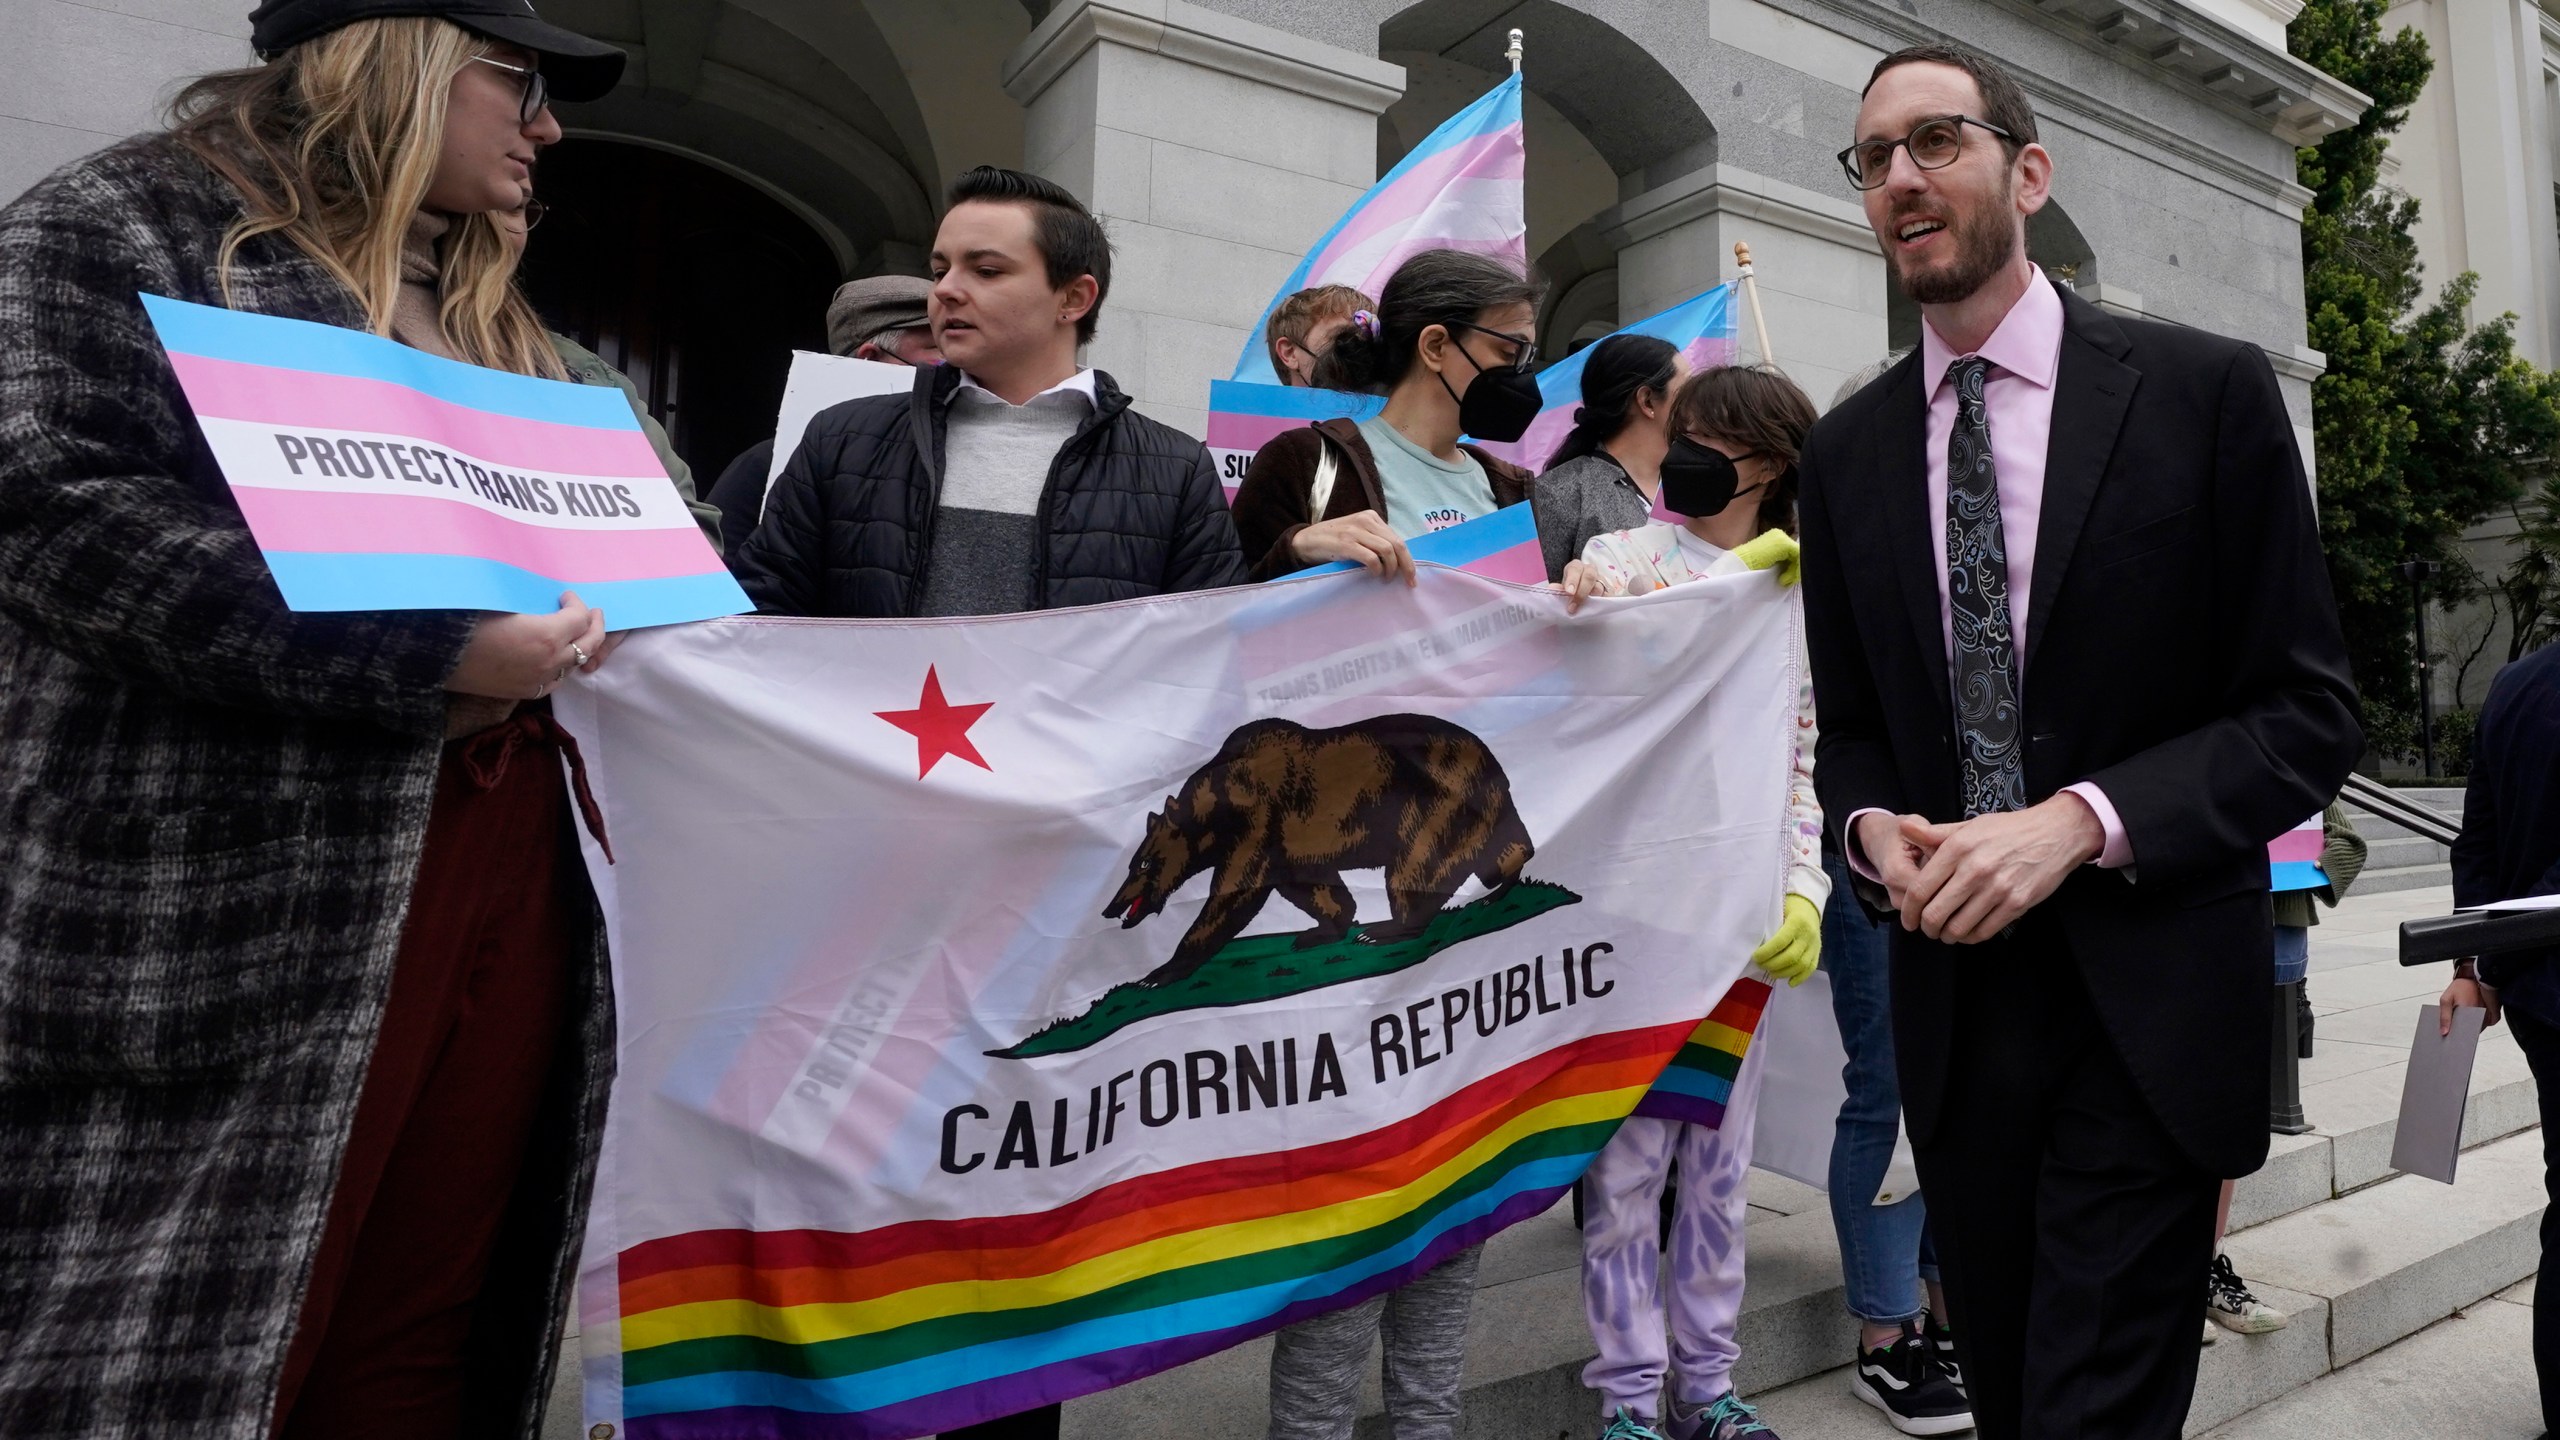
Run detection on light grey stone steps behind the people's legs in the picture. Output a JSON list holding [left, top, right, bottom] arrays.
[[1065, 881, 2542, 1440]]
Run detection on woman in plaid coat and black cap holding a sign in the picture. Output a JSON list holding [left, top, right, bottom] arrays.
[[0, 0, 620, 1440]]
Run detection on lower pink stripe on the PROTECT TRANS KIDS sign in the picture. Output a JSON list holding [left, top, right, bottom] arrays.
[[233, 484, 719, 584]]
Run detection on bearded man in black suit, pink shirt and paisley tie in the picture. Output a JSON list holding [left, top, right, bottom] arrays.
[[1802, 49, 2363, 1440]]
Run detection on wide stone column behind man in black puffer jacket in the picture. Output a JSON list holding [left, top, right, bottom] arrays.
[[1004, 0, 1405, 436]]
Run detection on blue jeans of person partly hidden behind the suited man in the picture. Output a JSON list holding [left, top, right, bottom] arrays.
[[1823, 846, 1938, 1325]]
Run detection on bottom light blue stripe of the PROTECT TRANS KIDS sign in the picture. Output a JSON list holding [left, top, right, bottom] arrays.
[[266, 551, 755, 630]]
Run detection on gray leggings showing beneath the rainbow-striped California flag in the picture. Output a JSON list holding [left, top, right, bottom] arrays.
[[1270, 1245, 1485, 1440]]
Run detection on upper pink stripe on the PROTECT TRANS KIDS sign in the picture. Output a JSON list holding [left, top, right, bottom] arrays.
[[169, 351, 666, 479]]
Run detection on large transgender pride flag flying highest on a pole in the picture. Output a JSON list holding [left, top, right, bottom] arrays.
[[1234, 74, 1528, 384]]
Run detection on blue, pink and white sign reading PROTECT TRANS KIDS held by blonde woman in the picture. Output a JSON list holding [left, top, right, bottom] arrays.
[[143, 295, 750, 630]]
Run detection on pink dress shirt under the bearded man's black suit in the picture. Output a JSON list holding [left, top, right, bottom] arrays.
[[1848, 277, 2132, 879]]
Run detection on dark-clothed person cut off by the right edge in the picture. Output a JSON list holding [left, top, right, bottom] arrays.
[[2442, 646, 2560, 1432]]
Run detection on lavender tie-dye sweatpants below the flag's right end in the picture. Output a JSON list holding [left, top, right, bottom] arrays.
[[1582, 1024, 1766, 1425]]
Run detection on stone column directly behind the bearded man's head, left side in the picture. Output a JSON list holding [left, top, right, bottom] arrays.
[[1597, 164, 1887, 410]]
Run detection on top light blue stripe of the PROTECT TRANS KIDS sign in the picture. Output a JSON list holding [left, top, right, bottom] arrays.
[[141, 295, 640, 427]]
